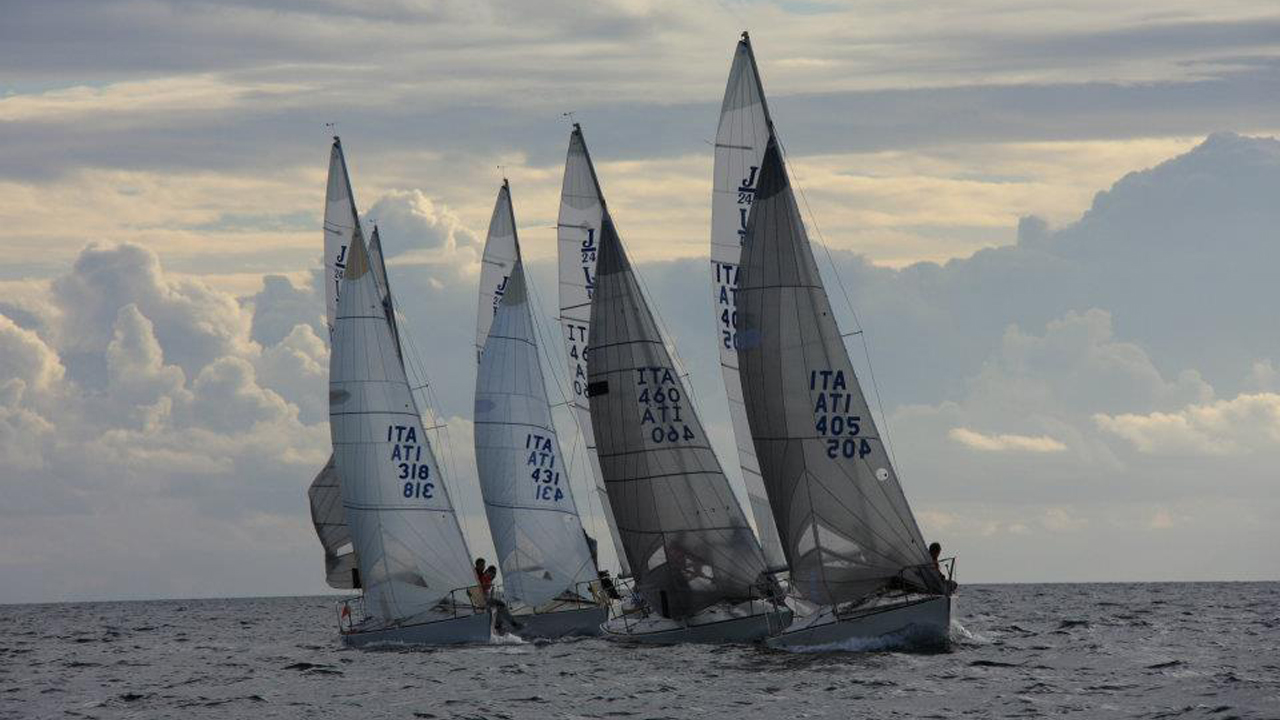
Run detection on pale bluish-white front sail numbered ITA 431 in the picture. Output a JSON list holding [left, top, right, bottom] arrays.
[[475, 252, 595, 607]]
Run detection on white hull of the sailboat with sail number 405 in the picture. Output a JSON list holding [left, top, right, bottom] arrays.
[[765, 596, 952, 650]]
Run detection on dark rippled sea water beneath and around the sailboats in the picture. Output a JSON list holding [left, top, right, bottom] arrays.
[[0, 583, 1280, 720]]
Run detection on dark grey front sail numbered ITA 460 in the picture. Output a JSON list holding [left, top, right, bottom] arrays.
[[588, 215, 765, 618]]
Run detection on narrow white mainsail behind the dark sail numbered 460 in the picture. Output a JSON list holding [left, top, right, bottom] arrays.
[[557, 123, 631, 575]]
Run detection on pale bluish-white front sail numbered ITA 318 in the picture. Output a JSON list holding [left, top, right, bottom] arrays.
[[329, 230, 475, 623]]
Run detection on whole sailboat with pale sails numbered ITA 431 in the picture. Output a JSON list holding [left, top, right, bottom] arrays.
[[475, 181, 609, 638]]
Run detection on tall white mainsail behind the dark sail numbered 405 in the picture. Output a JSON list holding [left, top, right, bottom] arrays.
[[712, 32, 786, 570]]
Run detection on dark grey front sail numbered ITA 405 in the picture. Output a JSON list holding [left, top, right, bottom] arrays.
[[737, 138, 937, 605]]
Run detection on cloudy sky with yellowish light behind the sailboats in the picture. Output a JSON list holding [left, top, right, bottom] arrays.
[[0, 0, 1280, 602]]
